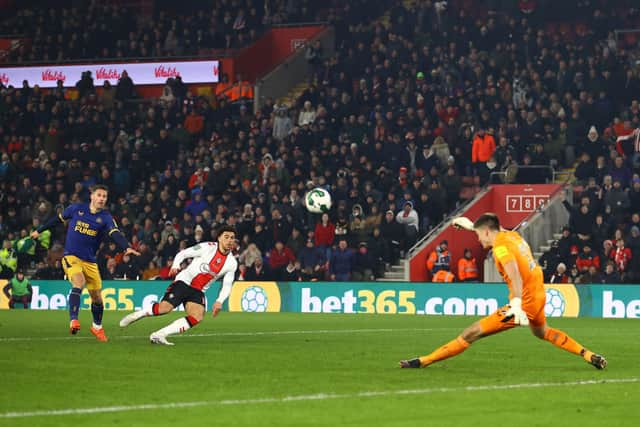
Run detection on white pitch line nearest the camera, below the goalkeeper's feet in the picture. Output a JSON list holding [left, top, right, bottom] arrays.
[[0, 377, 640, 418]]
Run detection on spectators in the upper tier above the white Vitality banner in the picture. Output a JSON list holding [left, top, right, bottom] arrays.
[[0, 0, 332, 63]]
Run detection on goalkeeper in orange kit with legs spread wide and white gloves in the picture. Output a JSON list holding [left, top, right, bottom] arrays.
[[400, 213, 607, 369]]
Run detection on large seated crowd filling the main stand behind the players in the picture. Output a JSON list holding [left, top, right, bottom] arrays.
[[0, 1, 640, 280]]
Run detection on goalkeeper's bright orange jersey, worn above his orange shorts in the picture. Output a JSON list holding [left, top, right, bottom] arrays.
[[493, 231, 545, 307]]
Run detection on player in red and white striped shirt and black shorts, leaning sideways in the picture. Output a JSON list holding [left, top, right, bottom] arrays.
[[120, 225, 238, 345]]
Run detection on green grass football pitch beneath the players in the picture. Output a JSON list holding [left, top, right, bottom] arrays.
[[0, 310, 640, 427]]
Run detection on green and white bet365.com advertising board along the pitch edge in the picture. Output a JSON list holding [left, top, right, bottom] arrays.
[[0, 280, 640, 318]]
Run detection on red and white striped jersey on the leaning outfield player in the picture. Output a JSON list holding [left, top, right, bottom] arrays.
[[172, 242, 238, 302]]
